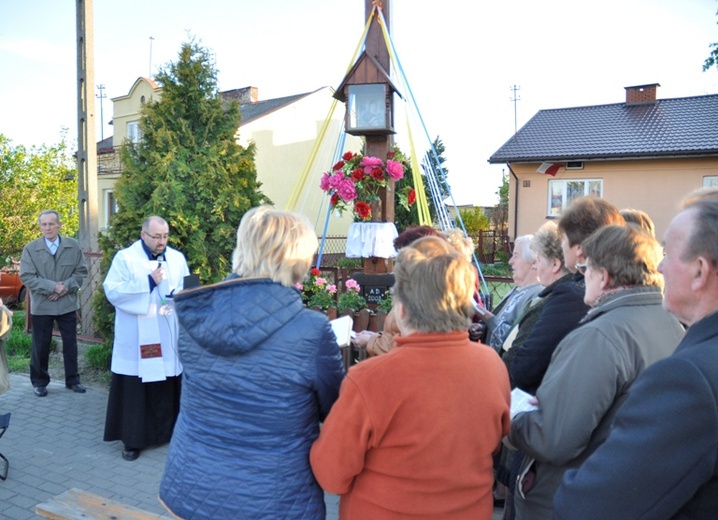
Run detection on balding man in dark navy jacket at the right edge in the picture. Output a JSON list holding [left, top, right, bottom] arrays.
[[554, 189, 718, 520]]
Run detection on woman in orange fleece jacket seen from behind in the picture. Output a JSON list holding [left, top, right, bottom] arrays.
[[311, 237, 510, 520]]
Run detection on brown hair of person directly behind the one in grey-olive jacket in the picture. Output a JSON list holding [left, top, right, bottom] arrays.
[[558, 195, 626, 250]]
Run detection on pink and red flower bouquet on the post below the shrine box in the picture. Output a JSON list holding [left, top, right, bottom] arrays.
[[319, 152, 416, 221]]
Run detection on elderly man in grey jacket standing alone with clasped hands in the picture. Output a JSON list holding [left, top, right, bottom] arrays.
[[20, 210, 87, 397]]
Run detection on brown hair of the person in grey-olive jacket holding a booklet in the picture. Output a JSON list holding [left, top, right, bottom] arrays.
[[581, 226, 663, 287]]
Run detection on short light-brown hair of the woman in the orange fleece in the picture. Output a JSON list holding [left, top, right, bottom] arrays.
[[394, 236, 475, 332]]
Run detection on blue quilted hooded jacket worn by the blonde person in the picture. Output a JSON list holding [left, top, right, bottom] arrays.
[[160, 278, 344, 520]]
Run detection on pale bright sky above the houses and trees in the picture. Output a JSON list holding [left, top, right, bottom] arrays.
[[0, 0, 718, 205]]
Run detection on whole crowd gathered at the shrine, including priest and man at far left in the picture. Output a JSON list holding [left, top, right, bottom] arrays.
[[15, 188, 718, 520]]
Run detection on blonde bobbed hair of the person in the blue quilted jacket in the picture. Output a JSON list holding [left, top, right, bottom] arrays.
[[232, 206, 319, 287]]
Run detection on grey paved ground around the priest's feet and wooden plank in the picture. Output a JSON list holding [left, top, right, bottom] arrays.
[[0, 374, 500, 520]]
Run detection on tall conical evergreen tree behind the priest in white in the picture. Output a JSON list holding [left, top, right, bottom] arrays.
[[94, 40, 269, 341]]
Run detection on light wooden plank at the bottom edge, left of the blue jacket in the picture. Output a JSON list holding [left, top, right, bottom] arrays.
[[35, 488, 162, 520]]
